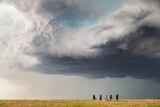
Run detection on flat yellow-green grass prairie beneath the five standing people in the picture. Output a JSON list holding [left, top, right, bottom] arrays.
[[0, 100, 160, 107]]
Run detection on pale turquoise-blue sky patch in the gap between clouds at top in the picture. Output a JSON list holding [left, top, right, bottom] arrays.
[[50, 0, 121, 27]]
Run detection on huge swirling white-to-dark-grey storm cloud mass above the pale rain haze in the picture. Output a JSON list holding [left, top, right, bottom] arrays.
[[0, 0, 160, 81]]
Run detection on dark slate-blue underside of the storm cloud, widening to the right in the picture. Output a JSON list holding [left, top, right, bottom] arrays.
[[31, 26, 160, 82]]
